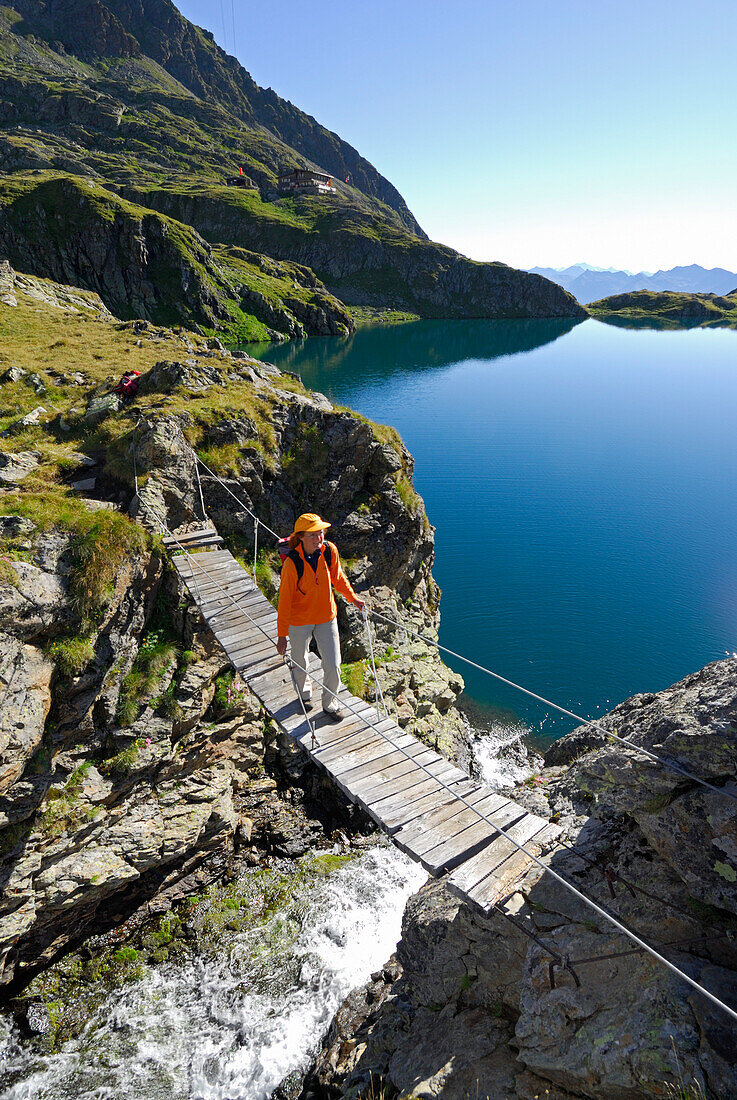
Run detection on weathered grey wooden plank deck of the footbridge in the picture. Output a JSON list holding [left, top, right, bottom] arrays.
[[172, 541, 560, 912]]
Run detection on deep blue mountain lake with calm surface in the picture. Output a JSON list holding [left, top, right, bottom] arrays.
[[249, 320, 737, 741]]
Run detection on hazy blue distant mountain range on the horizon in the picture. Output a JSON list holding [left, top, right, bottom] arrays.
[[528, 264, 737, 303]]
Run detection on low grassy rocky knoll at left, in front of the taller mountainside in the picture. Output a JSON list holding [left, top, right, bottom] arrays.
[[0, 175, 353, 341]]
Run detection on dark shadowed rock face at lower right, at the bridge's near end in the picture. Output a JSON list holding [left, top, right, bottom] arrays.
[[304, 659, 737, 1100]]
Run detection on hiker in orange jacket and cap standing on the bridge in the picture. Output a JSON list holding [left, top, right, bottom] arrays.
[[276, 512, 364, 722]]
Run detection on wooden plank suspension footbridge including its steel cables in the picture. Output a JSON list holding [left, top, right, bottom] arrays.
[[133, 435, 737, 1022]]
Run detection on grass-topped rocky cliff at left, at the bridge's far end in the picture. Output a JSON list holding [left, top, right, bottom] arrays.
[[0, 265, 463, 991]]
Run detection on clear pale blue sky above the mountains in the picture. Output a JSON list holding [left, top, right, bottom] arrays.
[[178, 0, 737, 271]]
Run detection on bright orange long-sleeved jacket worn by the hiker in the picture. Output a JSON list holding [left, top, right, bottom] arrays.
[[276, 542, 356, 638]]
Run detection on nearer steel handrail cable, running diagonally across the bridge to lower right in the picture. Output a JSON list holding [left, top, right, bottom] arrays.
[[135, 505, 737, 1022]]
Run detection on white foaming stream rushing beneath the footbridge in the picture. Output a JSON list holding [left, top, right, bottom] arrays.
[[0, 847, 426, 1100]]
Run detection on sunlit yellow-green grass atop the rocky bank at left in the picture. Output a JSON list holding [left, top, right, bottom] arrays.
[[0, 271, 397, 545]]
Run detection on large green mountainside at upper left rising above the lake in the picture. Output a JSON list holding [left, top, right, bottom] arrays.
[[0, 0, 586, 327]]
